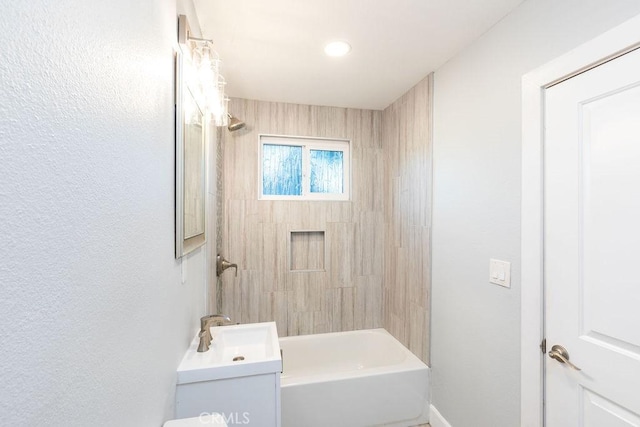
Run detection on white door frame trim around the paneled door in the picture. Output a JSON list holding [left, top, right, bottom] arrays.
[[520, 15, 640, 427]]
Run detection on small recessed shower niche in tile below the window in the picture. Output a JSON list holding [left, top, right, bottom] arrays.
[[289, 230, 325, 272]]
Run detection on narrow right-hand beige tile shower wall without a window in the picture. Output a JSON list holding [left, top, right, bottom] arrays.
[[382, 75, 432, 364]]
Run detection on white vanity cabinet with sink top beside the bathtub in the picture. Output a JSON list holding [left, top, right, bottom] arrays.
[[176, 322, 282, 427]]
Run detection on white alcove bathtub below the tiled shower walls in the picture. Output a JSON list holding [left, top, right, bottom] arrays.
[[280, 329, 429, 427]]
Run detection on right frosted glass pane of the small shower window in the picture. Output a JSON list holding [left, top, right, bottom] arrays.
[[309, 150, 344, 194]]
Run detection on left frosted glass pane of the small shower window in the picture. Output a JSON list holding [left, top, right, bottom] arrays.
[[262, 144, 302, 196]]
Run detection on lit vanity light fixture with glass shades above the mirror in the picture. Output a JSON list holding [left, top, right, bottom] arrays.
[[178, 15, 229, 126]]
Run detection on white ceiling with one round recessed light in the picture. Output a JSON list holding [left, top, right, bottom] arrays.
[[194, 0, 523, 110]]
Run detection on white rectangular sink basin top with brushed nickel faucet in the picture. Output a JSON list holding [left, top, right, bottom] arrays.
[[178, 322, 282, 384]]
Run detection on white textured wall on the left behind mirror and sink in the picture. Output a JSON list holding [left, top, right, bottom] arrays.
[[0, 0, 205, 427]]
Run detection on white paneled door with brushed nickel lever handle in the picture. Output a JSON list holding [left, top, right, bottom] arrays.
[[544, 46, 640, 427]]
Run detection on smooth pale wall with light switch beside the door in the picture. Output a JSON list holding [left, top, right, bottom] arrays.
[[431, 0, 640, 427]]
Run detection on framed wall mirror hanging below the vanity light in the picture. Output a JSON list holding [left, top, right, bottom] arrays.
[[175, 52, 207, 258]]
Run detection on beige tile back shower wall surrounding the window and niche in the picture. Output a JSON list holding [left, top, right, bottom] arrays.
[[215, 99, 384, 336]]
